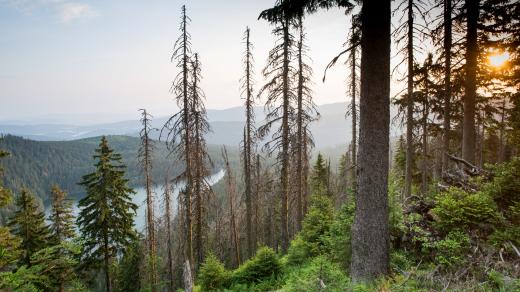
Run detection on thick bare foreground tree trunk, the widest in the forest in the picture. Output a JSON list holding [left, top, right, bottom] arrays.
[[351, 0, 391, 282]]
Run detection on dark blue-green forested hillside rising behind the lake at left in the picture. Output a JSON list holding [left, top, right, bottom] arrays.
[[0, 136, 232, 203]]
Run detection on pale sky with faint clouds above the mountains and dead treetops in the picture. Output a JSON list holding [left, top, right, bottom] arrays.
[[0, 0, 414, 123]]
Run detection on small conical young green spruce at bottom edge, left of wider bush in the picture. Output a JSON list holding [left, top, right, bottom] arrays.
[[198, 253, 231, 291]]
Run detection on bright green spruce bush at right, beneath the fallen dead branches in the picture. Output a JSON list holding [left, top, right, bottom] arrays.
[[432, 188, 500, 233]]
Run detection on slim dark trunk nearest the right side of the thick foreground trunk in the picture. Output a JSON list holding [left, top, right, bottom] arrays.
[[404, 0, 414, 197]]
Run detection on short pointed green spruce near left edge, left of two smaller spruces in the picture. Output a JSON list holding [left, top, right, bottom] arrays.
[[8, 189, 50, 267]]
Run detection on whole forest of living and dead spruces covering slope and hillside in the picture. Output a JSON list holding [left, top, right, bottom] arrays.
[[0, 0, 520, 292]]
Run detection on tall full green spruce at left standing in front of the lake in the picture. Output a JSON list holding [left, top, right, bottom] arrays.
[[77, 136, 137, 292]]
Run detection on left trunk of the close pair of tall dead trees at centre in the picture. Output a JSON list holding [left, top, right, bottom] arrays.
[[280, 19, 290, 252]]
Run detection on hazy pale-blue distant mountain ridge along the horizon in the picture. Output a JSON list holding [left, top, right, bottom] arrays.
[[0, 102, 398, 148]]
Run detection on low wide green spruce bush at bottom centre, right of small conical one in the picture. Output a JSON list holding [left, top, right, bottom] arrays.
[[232, 247, 282, 284]]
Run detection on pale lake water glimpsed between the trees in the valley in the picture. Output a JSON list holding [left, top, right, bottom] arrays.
[[45, 169, 226, 232]]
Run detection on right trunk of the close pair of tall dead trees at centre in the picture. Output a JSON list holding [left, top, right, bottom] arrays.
[[296, 15, 304, 232]]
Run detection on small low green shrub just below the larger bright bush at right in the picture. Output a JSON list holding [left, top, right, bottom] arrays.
[[425, 231, 470, 268]]
